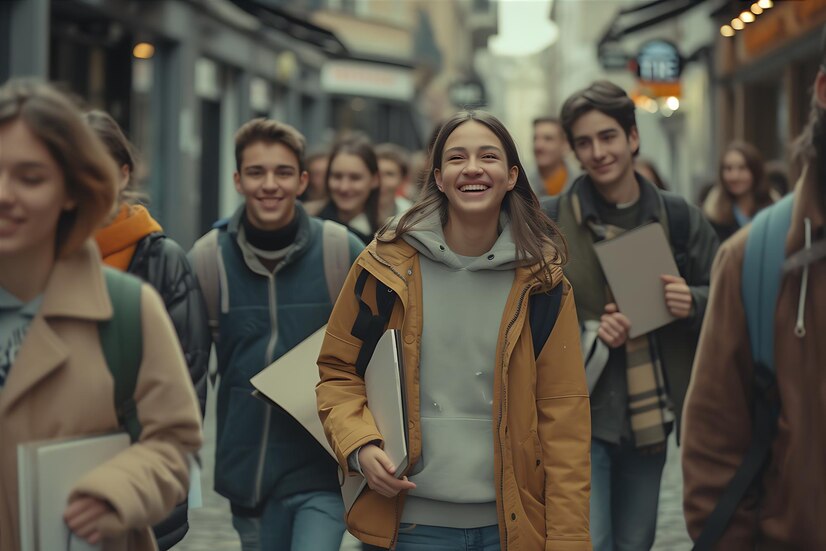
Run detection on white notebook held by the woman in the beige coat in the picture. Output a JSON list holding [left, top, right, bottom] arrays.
[[17, 433, 130, 551]]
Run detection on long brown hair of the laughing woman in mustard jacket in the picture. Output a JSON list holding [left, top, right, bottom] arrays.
[[377, 111, 568, 281]]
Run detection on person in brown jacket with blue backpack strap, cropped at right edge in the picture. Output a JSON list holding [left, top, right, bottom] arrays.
[[683, 33, 826, 550]]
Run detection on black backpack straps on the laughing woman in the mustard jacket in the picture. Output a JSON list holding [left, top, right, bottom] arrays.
[[350, 270, 562, 378]]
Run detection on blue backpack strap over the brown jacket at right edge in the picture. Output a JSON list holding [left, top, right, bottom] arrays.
[[694, 194, 794, 551]]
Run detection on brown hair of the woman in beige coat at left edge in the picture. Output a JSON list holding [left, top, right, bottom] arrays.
[[0, 79, 118, 257]]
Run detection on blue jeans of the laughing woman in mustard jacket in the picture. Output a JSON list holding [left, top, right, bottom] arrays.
[[396, 524, 500, 551]]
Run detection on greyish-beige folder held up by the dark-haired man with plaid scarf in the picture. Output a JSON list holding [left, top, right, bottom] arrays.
[[596, 222, 680, 338]]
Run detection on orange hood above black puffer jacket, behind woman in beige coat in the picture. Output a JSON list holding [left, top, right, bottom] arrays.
[[95, 203, 163, 272]]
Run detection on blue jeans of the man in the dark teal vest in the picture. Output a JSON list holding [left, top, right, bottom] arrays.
[[232, 492, 344, 551]]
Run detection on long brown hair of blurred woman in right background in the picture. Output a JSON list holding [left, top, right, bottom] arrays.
[[703, 141, 773, 225]]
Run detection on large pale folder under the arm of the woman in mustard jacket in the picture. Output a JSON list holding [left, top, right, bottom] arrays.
[[250, 326, 407, 511]]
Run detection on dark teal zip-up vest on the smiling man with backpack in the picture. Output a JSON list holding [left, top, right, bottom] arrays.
[[193, 205, 363, 516]]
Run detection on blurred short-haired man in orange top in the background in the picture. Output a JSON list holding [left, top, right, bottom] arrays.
[[529, 117, 574, 198]]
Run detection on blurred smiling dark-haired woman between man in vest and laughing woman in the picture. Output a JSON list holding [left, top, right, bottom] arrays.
[[318, 136, 380, 245]]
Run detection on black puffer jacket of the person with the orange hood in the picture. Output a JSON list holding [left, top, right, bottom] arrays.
[[127, 232, 212, 550]]
